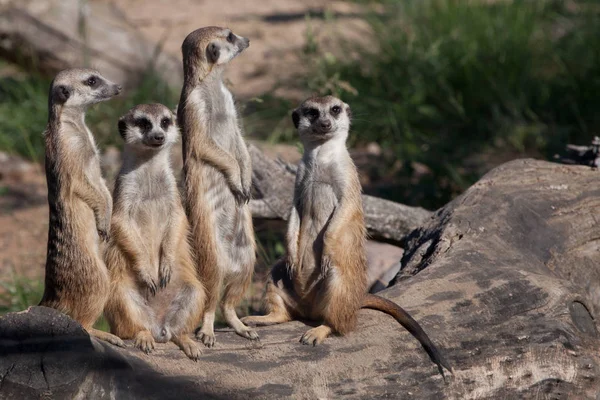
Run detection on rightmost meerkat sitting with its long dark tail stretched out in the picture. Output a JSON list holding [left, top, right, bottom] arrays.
[[242, 96, 451, 374]]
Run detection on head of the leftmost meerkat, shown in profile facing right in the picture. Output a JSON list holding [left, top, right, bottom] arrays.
[[49, 68, 121, 108]]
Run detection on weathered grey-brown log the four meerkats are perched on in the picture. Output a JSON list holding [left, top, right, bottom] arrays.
[[0, 160, 600, 400]]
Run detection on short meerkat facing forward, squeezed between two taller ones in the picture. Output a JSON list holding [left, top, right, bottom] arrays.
[[104, 104, 205, 360]]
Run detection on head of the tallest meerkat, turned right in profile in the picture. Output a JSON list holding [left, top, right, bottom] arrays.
[[181, 26, 250, 78]]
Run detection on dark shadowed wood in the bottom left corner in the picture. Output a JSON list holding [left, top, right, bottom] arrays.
[[0, 307, 218, 399]]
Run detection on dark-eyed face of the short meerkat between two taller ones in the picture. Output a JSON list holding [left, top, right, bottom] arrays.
[[119, 104, 178, 150]]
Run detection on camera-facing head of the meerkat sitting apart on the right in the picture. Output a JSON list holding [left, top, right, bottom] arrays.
[[292, 96, 352, 142]]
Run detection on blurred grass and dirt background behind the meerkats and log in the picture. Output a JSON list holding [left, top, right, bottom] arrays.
[[0, 0, 600, 327]]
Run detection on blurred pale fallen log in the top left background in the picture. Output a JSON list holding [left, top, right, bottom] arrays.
[[0, 0, 182, 86]]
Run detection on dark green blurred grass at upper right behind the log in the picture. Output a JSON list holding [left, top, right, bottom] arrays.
[[256, 0, 600, 208]]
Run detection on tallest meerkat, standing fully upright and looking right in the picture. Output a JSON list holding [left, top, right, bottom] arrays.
[[177, 27, 258, 347]]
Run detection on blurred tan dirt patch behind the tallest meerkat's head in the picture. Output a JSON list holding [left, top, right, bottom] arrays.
[[108, 0, 368, 98]]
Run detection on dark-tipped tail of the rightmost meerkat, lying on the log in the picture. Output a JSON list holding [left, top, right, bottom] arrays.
[[361, 294, 453, 376]]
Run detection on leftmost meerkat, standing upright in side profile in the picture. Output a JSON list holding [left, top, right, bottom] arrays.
[[40, 68, 124, 346]]
